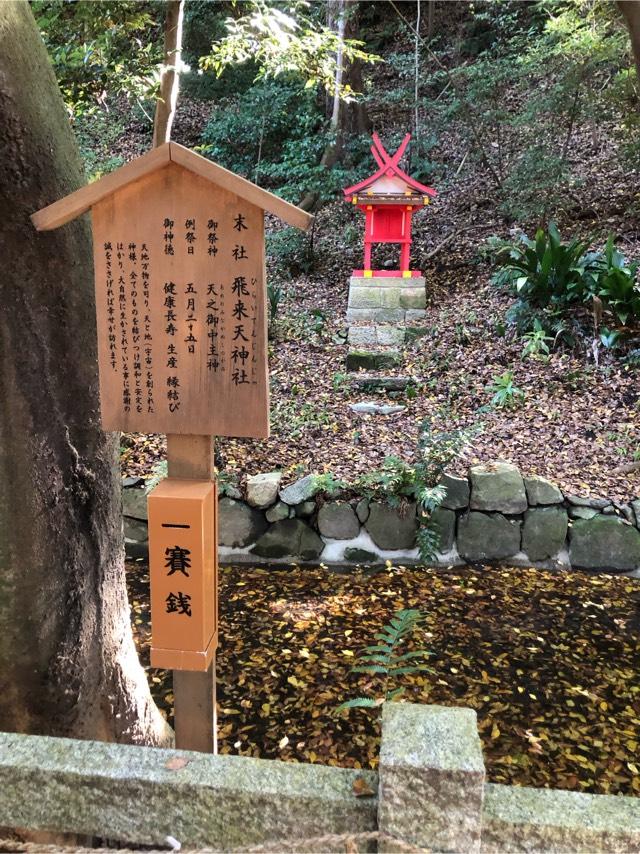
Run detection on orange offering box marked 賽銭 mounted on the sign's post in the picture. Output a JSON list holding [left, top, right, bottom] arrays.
[[148, 478, 218, 671]]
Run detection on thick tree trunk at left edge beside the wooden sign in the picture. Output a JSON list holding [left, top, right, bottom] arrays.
[[0, 0, 170, 744]]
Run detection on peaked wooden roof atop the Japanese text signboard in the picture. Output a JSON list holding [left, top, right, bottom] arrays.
[[31, 142, 313, 231]]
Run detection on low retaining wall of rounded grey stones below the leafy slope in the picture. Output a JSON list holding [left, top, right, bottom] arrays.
[[123, 462, 640, 574]]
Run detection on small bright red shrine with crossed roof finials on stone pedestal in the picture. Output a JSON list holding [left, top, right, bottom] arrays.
[[344, 133, 436, 278]]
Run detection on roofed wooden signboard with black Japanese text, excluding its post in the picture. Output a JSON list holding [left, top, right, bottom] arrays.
[[32, 142, 313, 438]]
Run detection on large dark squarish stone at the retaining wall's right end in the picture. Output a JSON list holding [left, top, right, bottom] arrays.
[[569, 516, 640, 571]]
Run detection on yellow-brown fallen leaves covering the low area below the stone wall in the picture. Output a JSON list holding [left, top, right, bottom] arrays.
[[127, 563, 640, 796]]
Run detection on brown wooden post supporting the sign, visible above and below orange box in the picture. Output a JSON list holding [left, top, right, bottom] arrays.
[[167, 433, 218, 753]]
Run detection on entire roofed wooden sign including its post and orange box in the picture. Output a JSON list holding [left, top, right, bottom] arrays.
[[32, 142, 313, 753]]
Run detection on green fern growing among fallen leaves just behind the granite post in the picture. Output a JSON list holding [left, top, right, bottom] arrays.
[[336, 609, 434, 712]]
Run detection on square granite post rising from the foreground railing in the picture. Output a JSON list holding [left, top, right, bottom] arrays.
[[378, 703, 485, 854]]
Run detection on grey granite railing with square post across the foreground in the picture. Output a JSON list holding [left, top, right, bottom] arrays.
[[0, 703, 640, 854]]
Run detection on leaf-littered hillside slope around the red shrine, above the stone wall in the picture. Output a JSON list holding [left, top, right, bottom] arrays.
[[117, 90, 640, 501]]
